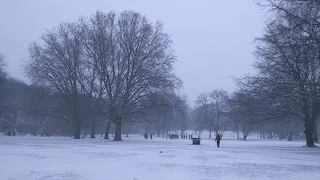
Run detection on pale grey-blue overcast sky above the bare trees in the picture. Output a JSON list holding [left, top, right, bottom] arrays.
[[0, 0, 264, 104]]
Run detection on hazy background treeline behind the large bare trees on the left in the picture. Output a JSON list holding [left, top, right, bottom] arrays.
[[0, 55, 188, 139]]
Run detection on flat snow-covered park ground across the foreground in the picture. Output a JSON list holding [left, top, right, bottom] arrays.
[[0, 135, 320, 180]]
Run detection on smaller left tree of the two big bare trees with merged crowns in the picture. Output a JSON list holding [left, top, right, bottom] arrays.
[[26, 23, 84, 139]]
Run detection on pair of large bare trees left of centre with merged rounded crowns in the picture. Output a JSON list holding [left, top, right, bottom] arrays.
[[26, 11, 181, 141]]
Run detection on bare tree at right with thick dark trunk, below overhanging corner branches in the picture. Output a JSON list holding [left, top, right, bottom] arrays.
[[239, 3, 319, 147]]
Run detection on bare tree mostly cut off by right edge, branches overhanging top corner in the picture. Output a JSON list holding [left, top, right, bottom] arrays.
[[257, 0, 320, 146]]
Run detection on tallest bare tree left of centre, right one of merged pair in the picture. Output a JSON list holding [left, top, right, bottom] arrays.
[[83, 11, 176, 141]]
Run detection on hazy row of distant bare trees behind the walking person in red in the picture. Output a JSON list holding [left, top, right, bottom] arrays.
[[191, 90, 308, 141]]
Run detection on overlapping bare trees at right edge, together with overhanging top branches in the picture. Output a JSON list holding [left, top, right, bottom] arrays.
[[240, 0, 320, 147]]
